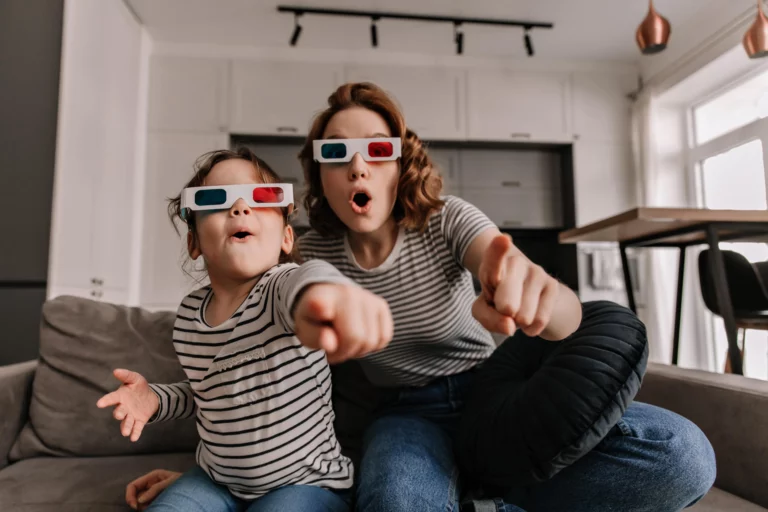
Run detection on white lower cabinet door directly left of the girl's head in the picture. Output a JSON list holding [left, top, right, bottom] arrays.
[[140, 133, 228, 308]]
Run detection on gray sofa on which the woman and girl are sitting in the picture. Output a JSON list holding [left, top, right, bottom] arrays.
[[0, 297, 768, 512]]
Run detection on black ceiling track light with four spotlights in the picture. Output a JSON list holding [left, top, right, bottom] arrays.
[[277, 5, 554, 57]]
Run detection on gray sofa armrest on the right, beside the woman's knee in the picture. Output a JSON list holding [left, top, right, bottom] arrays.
[[637, 364, 768, 507]]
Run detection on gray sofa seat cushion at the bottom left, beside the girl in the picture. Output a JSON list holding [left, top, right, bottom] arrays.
[[0, 453, 195, 512]]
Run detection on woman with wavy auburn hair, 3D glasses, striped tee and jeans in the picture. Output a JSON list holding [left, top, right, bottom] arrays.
[[128, 83, 714, 511]]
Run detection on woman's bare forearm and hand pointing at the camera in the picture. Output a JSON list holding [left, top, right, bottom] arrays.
[[463, 228, 581, 341]]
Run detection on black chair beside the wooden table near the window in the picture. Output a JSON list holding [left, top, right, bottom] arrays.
[[699, 249, 768, 373]]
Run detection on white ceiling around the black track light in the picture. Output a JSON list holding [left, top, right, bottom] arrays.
[[124, 0, 724, 62]]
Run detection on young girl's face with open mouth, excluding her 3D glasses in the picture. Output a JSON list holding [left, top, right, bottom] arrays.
[[187, 159, 293, 280]]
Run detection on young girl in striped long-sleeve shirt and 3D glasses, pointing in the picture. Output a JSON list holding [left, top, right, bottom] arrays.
[[98, 149, 392, 512]]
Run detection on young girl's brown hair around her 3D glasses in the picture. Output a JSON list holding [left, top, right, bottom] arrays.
[[168, 147, 293, 263]]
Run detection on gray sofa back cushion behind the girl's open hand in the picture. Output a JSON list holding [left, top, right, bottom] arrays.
[[9, 297, 198, 460]]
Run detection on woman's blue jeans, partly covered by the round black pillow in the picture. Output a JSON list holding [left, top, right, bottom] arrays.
[[356, 372, 715, 512]]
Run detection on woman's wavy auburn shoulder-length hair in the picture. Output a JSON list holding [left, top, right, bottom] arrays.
[[299, 82, 443, 236]]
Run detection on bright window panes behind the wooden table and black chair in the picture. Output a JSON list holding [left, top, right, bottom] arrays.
[[690, 73, 768, 379]]
